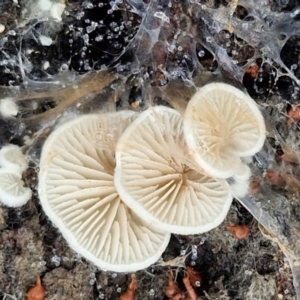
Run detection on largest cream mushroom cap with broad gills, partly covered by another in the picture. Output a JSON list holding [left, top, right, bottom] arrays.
[[38, 112, 170, 272]]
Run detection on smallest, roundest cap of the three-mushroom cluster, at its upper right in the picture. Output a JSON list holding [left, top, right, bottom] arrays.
[[184, 83, 266, 178]]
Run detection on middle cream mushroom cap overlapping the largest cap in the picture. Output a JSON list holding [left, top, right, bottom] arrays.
[[115, 106, 232, 234]]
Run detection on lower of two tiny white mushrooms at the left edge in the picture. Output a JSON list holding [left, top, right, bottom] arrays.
[[0, 168, 32, 207]]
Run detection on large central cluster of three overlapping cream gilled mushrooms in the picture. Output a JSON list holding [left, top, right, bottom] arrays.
[[39, 84, 265, 272]]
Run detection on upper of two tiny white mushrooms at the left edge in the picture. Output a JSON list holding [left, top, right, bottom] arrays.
[[0, 144, 28, 173]]
